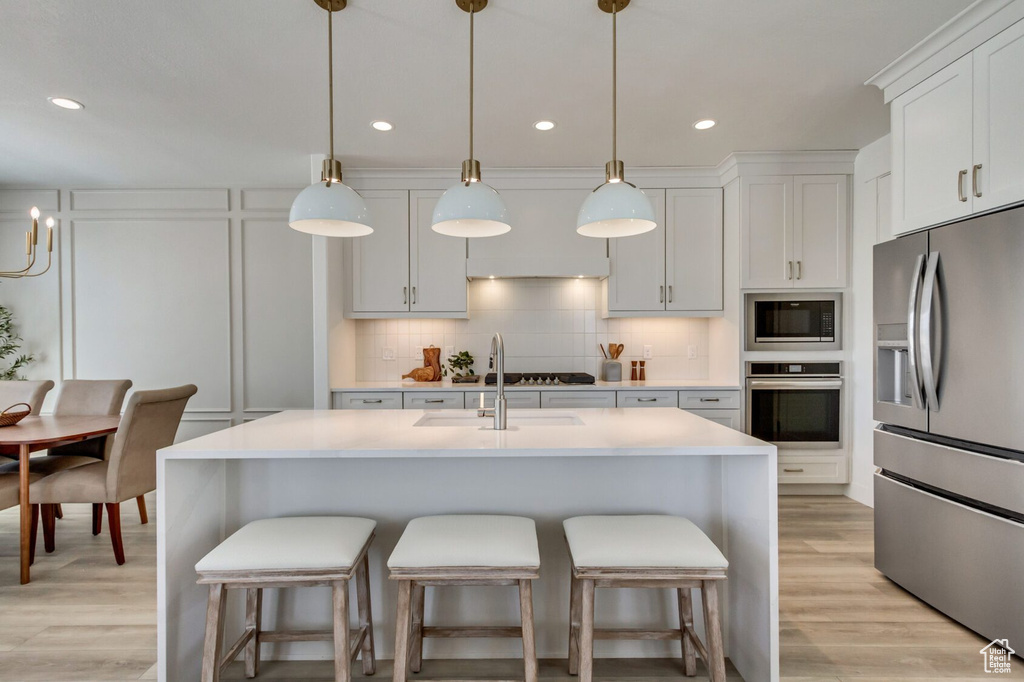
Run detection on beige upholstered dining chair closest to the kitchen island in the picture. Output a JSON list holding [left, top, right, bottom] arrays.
[[29, 384, 197, 564]]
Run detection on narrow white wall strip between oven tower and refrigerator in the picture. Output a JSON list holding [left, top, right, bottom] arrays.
[[846, 135, 892, 505]]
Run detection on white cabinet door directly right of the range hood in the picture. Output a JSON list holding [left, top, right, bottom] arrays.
[[607, 189, 666, 311]]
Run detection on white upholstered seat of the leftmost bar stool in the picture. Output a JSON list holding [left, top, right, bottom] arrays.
[[196, 516, 377, 573]]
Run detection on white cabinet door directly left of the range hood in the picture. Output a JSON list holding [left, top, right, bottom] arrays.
[[409, 191, 467, 313]]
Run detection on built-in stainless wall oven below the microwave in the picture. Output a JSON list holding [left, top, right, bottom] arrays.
[[746, 363, 843, 450]]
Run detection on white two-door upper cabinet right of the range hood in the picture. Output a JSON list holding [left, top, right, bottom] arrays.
[[604, 187, 723, 317]]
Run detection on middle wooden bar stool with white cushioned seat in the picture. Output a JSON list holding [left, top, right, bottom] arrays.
[[387, 515, 541, 682]]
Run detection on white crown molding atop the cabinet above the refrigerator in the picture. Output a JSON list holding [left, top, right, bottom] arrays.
[[864, 0, 1024, 103]]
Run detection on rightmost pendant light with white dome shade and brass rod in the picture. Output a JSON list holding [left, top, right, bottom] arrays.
[[577, 0, 657, 240]]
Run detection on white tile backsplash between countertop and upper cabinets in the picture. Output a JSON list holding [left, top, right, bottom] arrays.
[[355, 280, 710, 381]]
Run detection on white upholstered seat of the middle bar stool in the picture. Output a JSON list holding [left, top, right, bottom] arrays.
[[387, 514, 541, 570]]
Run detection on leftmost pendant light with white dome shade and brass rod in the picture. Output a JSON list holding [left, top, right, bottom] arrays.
[[288, 0, 374, 237]]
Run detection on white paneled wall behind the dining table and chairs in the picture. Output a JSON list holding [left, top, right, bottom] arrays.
[[0, 188, 313, 438]]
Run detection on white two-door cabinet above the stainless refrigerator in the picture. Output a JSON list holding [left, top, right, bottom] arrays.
[[892, 22, 1024, 235]]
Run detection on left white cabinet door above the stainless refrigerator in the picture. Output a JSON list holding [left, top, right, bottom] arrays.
[[892, 54, 974, 235]]
